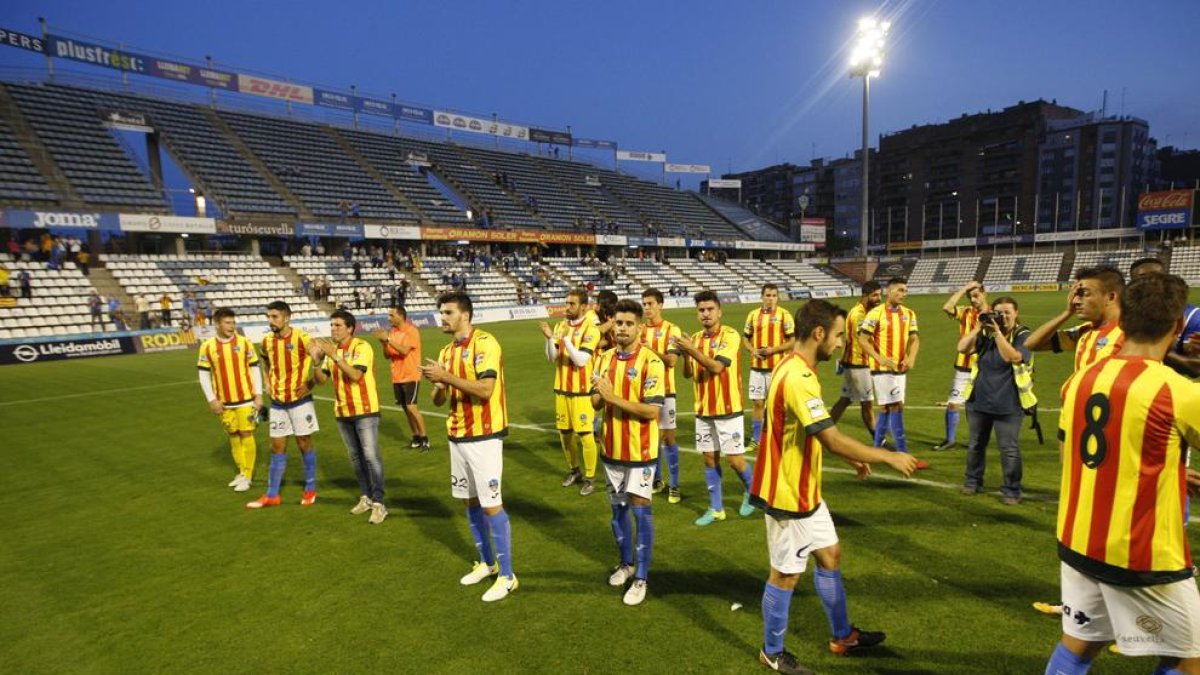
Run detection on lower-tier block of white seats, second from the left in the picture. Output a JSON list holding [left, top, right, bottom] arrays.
[[101, 253, 325, 319]]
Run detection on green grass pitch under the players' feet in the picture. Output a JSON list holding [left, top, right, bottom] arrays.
[[0, 288, 1196, 674]]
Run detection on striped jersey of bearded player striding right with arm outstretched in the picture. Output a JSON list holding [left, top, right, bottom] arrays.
[[750, 353, 833, 516]]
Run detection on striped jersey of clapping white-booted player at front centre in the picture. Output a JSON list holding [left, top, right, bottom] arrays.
[[596, 345, 666, 466]]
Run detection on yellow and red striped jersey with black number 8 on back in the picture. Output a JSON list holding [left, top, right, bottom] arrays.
[[1058, 354, 1200, 585]]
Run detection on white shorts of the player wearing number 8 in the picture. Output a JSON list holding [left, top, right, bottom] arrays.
[[1060, 562, 1200, 658]]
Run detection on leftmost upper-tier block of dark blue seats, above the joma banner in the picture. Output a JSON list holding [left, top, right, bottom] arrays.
[[6, 84, 167, 207]]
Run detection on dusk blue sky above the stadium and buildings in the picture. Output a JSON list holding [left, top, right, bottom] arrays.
[[0, 0, 1200, 186]]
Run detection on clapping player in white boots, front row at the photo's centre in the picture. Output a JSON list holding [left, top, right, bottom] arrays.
[[592, 300, 666, 607]]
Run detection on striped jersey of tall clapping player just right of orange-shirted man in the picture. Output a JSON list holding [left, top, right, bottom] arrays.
[[438, 328, 509, 441]]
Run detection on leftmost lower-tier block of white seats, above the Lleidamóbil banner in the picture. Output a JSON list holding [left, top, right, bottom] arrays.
[[0, 253, 103, 339]]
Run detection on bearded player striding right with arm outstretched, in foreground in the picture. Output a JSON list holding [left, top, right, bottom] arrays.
[[750, 300, 917, 674]]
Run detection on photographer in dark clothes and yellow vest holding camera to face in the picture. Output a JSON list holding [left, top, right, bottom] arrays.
[[959, 297, 1038, 506]]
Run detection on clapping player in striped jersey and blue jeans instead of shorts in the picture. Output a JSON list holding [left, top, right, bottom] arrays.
[[314, 310, 388, 525]]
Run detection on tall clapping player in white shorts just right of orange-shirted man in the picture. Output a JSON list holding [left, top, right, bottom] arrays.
[[421, 292, 517, 602]]
